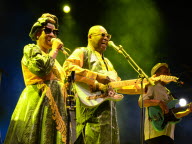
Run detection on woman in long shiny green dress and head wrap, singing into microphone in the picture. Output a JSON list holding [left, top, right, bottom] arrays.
[[4, 13, 67, 144]]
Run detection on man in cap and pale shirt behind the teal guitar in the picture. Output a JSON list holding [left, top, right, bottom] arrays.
[[138, 63, 192, 144]]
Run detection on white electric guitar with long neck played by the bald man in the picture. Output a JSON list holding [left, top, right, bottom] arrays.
[[74, 75, 178, 107]]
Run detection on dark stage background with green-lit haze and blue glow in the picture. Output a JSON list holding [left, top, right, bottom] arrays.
[[0, 0, 192, 144]]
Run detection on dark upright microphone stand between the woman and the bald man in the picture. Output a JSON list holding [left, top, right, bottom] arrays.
[[66, 71, 76, 144]]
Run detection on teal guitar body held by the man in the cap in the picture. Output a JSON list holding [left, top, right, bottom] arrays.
[[148, 99, 180, 131]]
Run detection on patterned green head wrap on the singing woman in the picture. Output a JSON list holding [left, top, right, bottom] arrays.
[[29, 13, 59, 41]]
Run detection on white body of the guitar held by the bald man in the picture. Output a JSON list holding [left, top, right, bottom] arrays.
[[74, 82, 123, 107]]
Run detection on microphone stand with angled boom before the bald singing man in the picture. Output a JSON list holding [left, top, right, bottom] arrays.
[[112, 45, 154, 144]]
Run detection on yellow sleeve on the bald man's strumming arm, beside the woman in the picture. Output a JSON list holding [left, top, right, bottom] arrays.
[[63, 48, 98, 85]]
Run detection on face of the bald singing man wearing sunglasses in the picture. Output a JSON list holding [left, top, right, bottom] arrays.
[[90, 27, 111, 53]]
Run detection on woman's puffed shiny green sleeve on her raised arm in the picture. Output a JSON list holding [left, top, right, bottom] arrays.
[[22, 44, 55, 77]]
